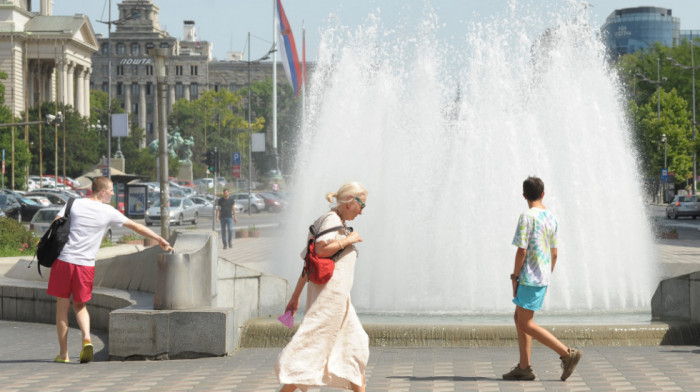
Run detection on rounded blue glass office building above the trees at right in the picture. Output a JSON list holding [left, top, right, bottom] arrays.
[[601, 7, 681, 56]]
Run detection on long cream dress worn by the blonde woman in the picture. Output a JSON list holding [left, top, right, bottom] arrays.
[[275, 211, 369, 391]]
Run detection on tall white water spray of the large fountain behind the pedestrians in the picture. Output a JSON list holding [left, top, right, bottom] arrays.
[[276, 1, 658, 315]]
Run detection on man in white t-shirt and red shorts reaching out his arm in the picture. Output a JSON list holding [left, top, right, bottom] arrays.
[[46, 177, 172, 363]]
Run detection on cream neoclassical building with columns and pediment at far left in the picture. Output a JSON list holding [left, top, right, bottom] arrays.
[[0, 0, 98, 116]]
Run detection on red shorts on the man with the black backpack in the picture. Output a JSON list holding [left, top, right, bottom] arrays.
[[46, 259, 95, 302]]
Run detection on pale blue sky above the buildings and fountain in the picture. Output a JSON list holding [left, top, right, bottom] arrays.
[[53, 0, 700, 61]]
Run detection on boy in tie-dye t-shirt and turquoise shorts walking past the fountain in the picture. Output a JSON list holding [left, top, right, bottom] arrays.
[[503, 177, 581, 381]]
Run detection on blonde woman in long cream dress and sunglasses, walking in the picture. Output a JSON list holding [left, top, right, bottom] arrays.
[[276, 182, 369, 392]]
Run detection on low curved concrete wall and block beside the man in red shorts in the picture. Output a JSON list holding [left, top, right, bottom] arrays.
[[0, 230, 289, 359]]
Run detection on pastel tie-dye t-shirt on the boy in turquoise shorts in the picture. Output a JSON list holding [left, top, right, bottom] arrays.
[[513, 207, 558, 287]]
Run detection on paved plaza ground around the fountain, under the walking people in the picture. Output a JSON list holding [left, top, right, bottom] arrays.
[[0, 224, 700, 392]]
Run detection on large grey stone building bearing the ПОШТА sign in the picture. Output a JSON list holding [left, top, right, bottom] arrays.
[[90, 0, 285, 146]]
